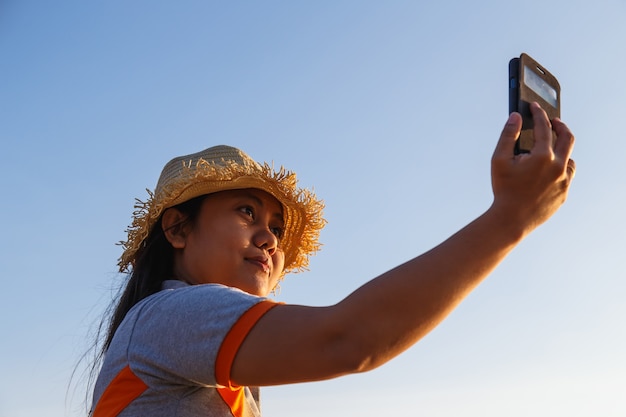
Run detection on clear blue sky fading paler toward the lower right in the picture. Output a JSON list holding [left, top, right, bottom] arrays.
[[0, 0, 626, 417]]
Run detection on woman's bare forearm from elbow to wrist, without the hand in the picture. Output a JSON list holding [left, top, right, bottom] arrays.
[[336, 203, 527, 370]]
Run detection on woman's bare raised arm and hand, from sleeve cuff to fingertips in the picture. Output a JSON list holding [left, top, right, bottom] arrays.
[[231, 104, 575, 386]]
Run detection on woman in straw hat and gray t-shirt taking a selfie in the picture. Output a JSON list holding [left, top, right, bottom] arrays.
[[92, 103, 575, 417]]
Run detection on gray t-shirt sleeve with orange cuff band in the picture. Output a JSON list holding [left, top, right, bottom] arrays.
[[128, 284, 276, 387]]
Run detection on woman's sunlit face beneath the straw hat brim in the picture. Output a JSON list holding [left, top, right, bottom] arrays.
[[174, 189, 285, 296]]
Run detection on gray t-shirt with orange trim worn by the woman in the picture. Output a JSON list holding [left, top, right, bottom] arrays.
[[92, 281, 276, 417]]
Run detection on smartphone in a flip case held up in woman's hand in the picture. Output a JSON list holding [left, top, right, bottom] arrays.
[[509, 53, 561, 155]]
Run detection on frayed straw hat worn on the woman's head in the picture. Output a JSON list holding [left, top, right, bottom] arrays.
[[118, 145, 326, 272]]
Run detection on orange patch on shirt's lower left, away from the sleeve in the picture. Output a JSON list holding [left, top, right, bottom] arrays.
[[92, 365, 148, 417]]
